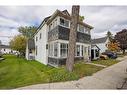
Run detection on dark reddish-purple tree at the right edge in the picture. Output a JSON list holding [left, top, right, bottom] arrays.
[[115, 29, 127, 54]]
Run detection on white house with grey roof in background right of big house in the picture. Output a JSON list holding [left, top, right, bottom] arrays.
[[92, 37, 109, 53]]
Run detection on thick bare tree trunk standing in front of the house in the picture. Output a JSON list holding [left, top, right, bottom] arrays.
[[66, 5, 80, 72]]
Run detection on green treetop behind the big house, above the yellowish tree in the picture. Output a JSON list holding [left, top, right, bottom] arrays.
[[18, 26, 37, 38]]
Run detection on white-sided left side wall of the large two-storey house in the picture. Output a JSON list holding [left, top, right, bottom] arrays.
[[34, 24, 47, 64]]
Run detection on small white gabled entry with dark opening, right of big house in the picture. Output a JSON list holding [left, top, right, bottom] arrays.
[[91, 45, 100, 60]]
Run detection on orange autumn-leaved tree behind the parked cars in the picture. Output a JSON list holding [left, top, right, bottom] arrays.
[[107, 39, 120, 52]]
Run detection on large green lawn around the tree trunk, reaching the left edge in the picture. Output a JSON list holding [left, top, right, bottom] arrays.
[[0, 55, 103, 89]]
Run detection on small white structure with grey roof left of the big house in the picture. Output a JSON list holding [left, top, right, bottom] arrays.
[[26, 39, 35, 60]]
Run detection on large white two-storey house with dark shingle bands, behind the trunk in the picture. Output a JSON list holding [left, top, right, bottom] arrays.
[[25, 10, 93, 66]]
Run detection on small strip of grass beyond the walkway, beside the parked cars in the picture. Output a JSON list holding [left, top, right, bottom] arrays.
[[92, 59, 119, 66]]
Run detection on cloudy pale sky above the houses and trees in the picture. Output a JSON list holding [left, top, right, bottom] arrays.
[[0, 6, 127, 44]]
